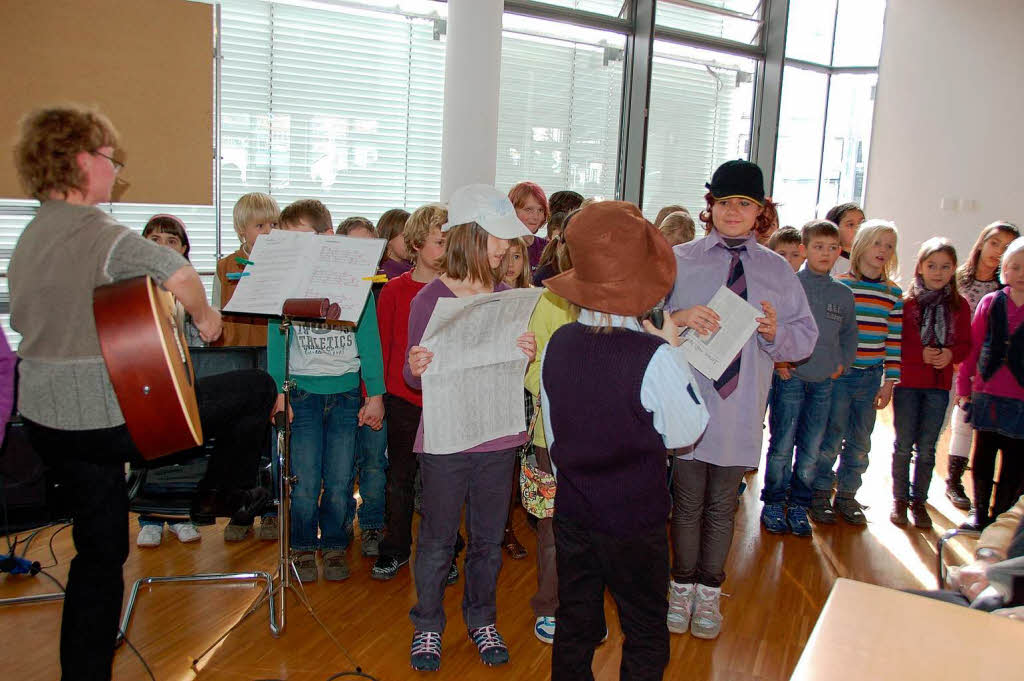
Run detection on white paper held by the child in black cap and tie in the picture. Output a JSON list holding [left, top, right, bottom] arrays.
[[682, 286, 764, 381]]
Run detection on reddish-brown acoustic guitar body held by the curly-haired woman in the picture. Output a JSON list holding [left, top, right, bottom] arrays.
[[92, 276, 203, 460]]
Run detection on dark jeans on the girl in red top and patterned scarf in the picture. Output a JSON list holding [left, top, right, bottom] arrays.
[[893, 386, 949, 503]]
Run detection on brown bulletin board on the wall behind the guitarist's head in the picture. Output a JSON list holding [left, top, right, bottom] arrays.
[[0, 0, 213, 205]]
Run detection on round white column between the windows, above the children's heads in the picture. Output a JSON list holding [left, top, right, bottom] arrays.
[[440, 0, 504, 201]]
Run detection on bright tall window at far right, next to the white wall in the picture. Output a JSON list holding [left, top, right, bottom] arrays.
[[773, 0, 885, 226]]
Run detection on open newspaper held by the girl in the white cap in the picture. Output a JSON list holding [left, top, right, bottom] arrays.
[[420, 288, 544, 454]]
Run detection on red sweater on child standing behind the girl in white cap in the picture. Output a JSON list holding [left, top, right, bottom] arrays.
[[377, 271, 426, 407]]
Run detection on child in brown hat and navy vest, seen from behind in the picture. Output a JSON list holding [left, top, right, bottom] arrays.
[[541, 202, 708, 681]]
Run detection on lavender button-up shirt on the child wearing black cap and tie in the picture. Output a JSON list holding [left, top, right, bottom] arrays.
[[666, 229, 818, 468]]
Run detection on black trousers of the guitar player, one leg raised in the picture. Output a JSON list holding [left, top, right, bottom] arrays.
[[27, 369, 278, 681]]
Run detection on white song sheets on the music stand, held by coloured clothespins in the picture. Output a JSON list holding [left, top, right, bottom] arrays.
[[224, 229, 386, 322]]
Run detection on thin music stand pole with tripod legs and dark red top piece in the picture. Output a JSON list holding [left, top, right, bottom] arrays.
[[193, 298, 359, 672]]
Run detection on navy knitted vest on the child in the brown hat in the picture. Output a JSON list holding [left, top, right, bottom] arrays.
[[544, 323, 671, 537]]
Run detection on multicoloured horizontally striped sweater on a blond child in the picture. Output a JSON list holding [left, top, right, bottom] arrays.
[[837, 274, 903, 381]]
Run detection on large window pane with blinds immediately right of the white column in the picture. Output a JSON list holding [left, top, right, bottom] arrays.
[[495, 14, 626, 199]]
